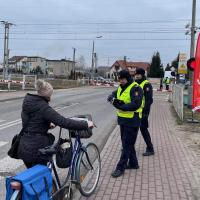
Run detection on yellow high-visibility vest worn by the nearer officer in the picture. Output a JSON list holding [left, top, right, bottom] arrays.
[[117, 82, 142, 118]]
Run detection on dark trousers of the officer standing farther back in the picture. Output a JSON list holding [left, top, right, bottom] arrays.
[[140, 116, 153, 151]]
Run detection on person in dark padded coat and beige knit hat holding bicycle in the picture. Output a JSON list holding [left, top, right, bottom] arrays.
[[18, 80, 93, 168]]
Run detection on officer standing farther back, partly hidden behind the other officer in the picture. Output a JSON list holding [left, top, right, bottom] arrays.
[[135, 68, 154, 156]]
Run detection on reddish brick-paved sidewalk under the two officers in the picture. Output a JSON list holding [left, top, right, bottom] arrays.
[[80, 92, 200, 200]]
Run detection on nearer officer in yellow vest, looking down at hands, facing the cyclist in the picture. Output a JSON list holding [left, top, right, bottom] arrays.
[[108, 70, 143, 178]]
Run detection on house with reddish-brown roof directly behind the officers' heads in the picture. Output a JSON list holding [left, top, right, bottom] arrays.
[[110, 60, 150, 79]]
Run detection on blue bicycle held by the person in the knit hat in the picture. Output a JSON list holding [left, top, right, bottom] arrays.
[[8, 115, 101, 200]]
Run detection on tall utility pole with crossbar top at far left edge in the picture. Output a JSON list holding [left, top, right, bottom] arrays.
[[1, 21, 14, 80]]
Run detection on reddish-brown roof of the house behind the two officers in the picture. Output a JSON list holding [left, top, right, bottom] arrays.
[[112, 60, 150, 71]]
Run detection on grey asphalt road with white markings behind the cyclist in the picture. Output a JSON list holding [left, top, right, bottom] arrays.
[[0, 87, 116, 199]]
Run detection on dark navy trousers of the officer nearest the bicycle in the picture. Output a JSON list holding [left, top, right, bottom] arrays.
[[117, 125, 139, 171]]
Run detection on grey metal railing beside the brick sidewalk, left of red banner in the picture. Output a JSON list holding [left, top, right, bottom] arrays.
[[172, 85, 184, 121]]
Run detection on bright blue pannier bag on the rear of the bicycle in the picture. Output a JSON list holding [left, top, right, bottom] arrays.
[[6, 165, 53, 200]]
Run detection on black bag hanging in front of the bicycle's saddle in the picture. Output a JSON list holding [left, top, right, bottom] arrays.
[[56, 138, 72, 168]]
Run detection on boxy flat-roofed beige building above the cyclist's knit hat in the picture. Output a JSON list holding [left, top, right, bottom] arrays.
[[46, 59, 75, 78]]
